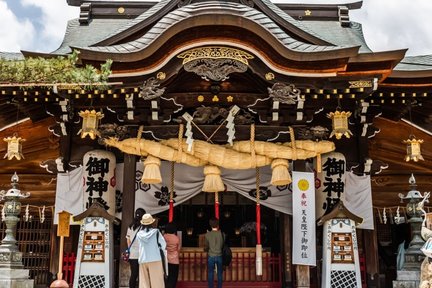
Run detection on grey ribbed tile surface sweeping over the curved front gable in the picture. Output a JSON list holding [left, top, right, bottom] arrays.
[[80, 1, 355, 53]]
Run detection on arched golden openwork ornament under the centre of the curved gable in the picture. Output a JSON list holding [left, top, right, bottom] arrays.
[[177, 46, 254, 65]]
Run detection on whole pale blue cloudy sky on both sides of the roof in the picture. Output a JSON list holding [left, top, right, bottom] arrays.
[[0, 0, 432, 55]]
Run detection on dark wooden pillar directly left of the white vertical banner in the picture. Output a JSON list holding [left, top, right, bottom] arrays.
[[280, 214, 293, 287]]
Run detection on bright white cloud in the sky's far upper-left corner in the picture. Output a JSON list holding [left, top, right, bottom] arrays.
[[0, 1, 35, 52]]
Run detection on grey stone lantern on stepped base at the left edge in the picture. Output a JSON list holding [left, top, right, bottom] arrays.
[[0, 172, 34, 288]]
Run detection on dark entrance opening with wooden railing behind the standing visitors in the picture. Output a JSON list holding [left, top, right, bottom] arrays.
[[156, 192, 282, 288]]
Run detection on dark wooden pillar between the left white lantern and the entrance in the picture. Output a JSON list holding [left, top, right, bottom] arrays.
[[119, 154, 136, 287]]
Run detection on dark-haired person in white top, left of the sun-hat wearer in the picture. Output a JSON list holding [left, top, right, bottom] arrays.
[[126, 208, 146, 288]]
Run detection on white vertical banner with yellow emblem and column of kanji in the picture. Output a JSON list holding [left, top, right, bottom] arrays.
[[292, 171, 316, 266]]
